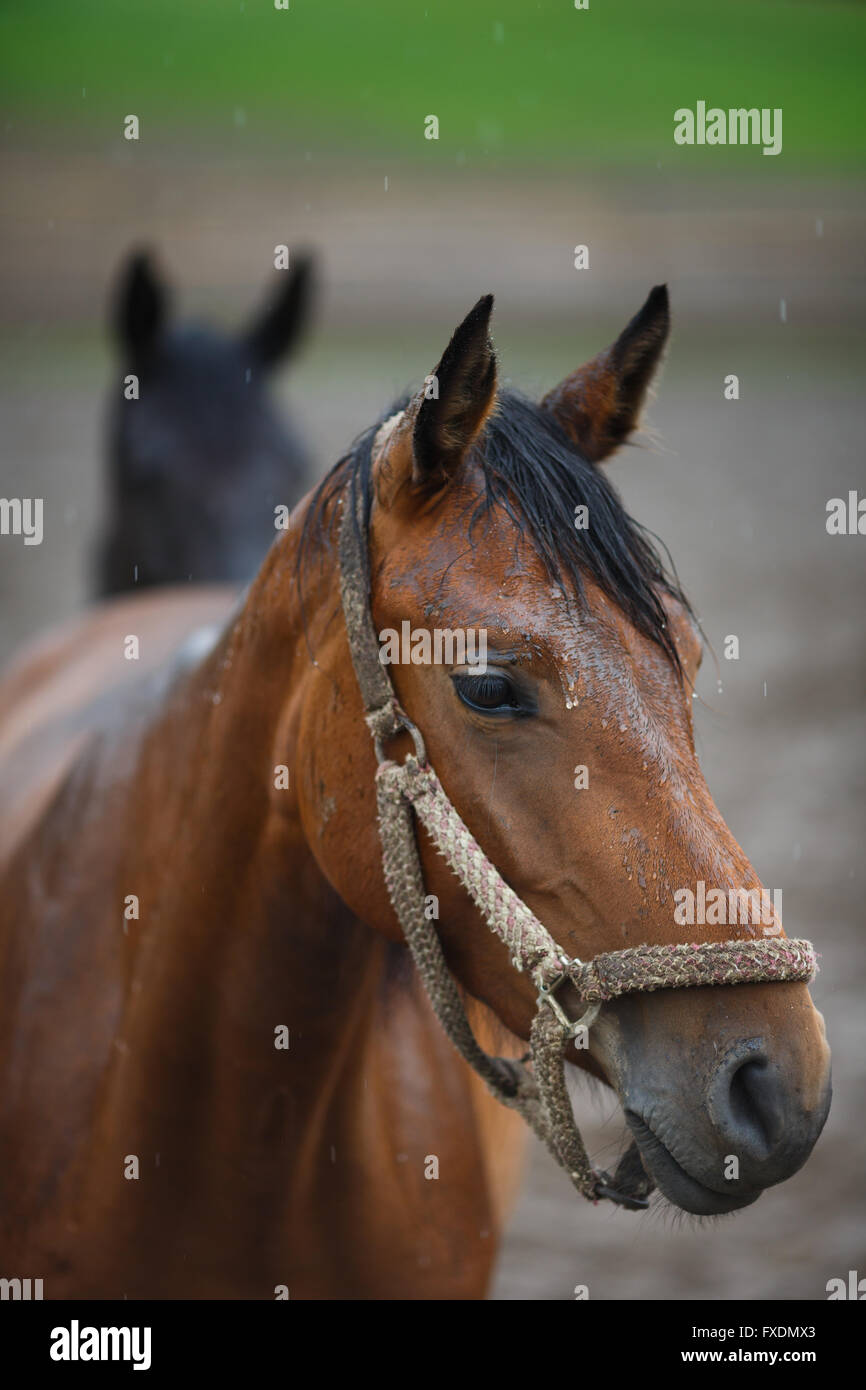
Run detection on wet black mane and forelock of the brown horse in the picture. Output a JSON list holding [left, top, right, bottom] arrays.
[[297, 391, 694, 678]]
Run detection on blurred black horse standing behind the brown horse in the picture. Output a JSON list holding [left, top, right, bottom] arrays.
[[96, 253, 313, 595]]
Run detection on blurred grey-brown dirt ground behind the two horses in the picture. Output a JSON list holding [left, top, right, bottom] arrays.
[[0, 149, 866, 1300]]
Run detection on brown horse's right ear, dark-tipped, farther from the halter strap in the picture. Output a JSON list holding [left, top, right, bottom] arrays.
[[541, 285, 670, 463]]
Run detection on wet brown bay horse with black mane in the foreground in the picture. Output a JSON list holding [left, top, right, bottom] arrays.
[[0, 289, 830, 1298]]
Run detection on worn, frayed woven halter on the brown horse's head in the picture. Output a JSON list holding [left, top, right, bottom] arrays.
[[339, 477, 816, 1209]]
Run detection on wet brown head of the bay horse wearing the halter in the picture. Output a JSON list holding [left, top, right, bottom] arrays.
[[300, 286, 830, 1215]]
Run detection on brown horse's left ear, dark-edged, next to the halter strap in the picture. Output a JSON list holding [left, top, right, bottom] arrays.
[[411, 295, 496, 485]]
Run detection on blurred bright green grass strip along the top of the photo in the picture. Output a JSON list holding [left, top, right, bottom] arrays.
[[0, 0, 866, 169]]
